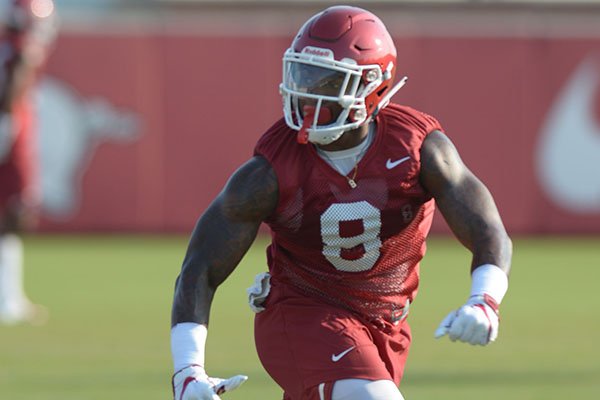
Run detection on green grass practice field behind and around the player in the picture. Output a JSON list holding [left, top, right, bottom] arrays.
[[0, 236, 600, 400]]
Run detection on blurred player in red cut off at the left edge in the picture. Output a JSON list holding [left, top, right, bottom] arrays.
[[0, 0, 57, 324]]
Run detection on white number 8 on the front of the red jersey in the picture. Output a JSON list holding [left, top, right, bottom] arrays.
[[321, 201, 381, 272]]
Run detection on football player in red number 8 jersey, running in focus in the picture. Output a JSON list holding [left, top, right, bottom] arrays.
[[171, 6, 512, 400]]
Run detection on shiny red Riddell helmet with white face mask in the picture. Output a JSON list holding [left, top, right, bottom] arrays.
[[280, 6, 406, 144]]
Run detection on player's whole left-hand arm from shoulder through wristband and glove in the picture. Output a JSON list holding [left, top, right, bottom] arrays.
[[171, 157, 278, 400]]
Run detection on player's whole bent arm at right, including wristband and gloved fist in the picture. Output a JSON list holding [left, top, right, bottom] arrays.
[[420, 131, 512, 345]]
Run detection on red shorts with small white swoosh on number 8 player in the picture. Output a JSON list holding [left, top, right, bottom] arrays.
[[254, 282, 411, 400]]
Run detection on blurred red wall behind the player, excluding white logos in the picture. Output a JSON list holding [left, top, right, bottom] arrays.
[[36, 24, 600, 233]]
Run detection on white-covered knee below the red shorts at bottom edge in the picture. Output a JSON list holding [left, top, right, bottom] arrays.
[[331, 379, 404, 400]]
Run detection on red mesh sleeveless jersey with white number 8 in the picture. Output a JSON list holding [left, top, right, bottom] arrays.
[[255, 104, 442, 322]]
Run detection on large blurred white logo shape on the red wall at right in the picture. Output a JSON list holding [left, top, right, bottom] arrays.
[[536, 56, 600, 214]]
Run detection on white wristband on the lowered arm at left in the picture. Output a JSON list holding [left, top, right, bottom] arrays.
[[171, 322, 208, 371]]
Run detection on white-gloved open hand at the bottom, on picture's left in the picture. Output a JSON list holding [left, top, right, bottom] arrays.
[[172, 365, 248, 400]]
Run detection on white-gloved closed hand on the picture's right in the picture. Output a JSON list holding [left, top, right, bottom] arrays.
[[435, 295, 499, 346]]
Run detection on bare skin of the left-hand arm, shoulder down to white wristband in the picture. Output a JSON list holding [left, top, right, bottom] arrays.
[[171, 157, 278, 326]]
